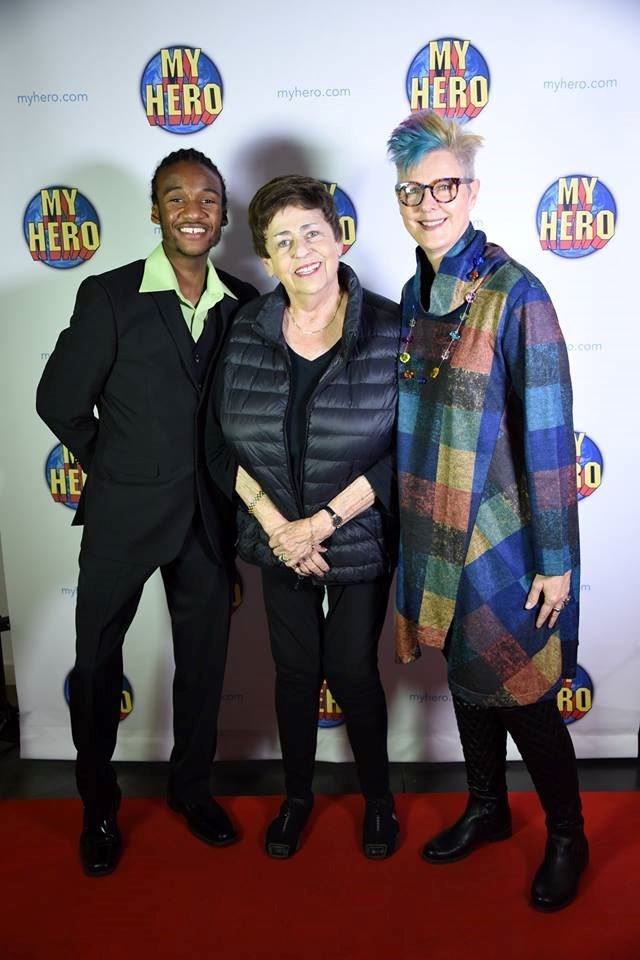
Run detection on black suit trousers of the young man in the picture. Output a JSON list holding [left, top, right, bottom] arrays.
[[69, 515, 231, 813]]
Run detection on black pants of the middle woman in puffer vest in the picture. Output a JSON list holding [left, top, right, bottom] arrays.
[[262, 568, 389, 799]]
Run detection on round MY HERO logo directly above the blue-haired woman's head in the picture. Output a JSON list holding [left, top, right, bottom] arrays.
[[406, 37, 489, 122]]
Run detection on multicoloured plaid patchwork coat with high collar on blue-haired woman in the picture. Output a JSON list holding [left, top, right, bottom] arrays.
[[396, 226, 580, 706]]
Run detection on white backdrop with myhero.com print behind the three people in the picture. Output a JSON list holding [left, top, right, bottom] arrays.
[[0, 0, 640, 760]]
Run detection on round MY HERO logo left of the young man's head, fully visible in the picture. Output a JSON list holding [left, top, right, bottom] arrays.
[[24, 187, 100, 267]]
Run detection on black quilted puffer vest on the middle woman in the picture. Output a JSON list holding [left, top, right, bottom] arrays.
[[218, 264, 400, 583]]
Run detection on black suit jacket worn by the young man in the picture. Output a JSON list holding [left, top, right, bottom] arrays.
[[37, 260, 257, 566]]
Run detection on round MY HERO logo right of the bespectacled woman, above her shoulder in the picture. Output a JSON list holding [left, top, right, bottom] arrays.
[[537, 175, 616, 257]]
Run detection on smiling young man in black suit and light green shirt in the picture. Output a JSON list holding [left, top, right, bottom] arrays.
[[37, 149, 257, 876]]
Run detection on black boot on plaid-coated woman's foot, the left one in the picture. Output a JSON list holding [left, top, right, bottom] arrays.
[[422, 794, 511, 863]]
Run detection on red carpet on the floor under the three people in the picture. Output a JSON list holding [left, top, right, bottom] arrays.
[[0, 793, 640, 960]]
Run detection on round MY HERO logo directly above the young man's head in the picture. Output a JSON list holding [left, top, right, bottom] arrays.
[[140, 47, 222, 133]]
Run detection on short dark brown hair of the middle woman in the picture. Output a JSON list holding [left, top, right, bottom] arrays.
[[249, 173, 342, 257]]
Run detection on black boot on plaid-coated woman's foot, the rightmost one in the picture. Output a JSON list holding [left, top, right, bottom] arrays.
[[531, 830, 589, 913]]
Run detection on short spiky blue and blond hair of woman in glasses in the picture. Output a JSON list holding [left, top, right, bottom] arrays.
[[387, 110, 482, 177]]
